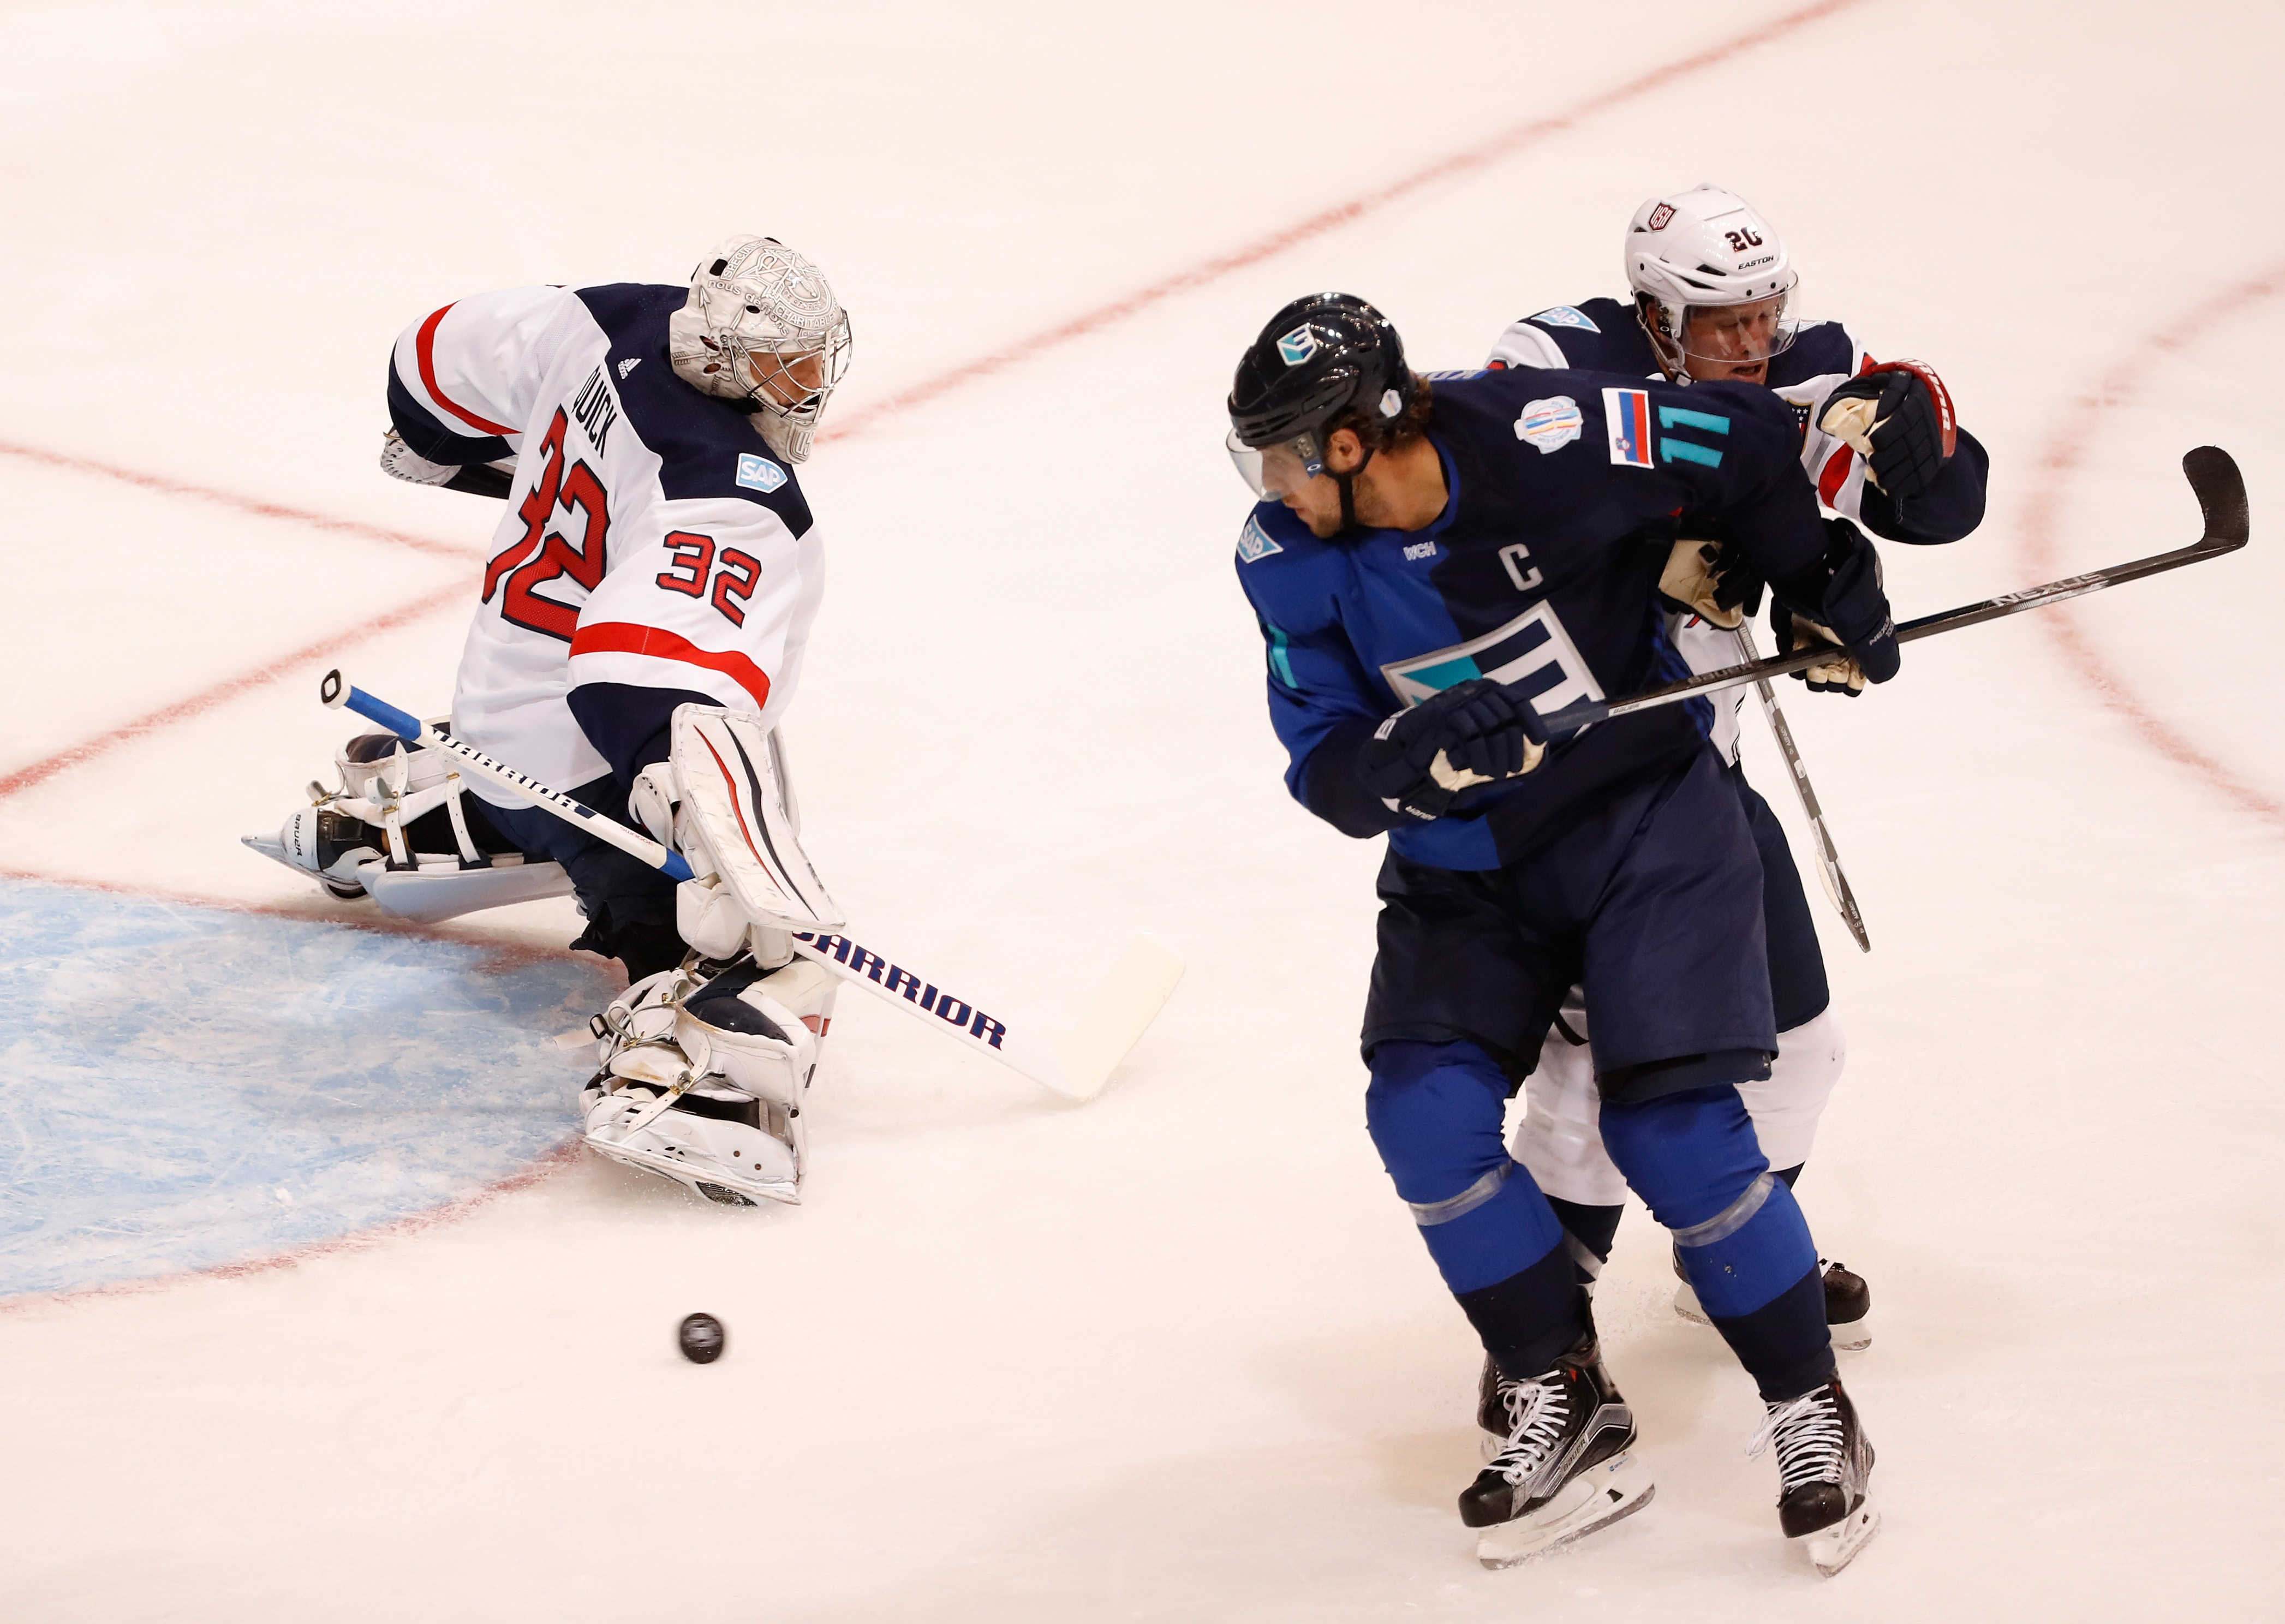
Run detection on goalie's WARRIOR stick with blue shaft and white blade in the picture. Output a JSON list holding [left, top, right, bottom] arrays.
[[318, 672, 1184, 1101]]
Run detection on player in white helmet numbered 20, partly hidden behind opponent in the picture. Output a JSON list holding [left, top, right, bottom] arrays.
[[1488, 185, 1988, 1348]]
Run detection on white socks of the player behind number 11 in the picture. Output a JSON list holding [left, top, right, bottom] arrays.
[[1513, 1005, 1848, 1206]]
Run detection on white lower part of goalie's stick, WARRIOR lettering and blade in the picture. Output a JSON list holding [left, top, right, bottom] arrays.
[[793, 932, 1184, 1103]]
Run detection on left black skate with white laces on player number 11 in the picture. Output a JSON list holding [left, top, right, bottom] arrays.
[[1460, 1336, 1657, 1567]]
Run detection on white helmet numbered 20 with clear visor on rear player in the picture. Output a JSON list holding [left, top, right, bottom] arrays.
[[1627, 185, 1798, 377]]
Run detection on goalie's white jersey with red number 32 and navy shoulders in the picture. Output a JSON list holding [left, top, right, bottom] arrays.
[[389, 283, 825, 804]]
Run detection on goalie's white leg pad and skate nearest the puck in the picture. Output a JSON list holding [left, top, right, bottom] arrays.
[[580, 959, 839, 1206]]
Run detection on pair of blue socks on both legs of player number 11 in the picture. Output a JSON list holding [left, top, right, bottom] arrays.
[[1364, 1042, 1833, 1402]]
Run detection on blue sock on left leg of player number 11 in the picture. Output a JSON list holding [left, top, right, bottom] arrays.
[[1364, 1042, 1586, 1375]]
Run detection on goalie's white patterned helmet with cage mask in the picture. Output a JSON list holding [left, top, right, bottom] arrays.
[[667, 235, 850, 462]]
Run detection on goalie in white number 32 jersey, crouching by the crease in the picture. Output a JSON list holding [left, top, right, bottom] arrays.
[[252, 235, 850, 1204]]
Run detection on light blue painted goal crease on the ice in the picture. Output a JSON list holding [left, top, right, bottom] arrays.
[[0, 882, 610, 1297]]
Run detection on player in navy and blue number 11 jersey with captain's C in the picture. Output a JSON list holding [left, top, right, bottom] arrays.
[[1230, 295, 1896, 1572]]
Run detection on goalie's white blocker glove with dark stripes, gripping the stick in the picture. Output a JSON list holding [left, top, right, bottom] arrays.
[[628, 706, 848, 959]]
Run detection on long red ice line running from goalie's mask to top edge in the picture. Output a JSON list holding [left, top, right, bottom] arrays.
[[822, 0, 1865, 441]]
